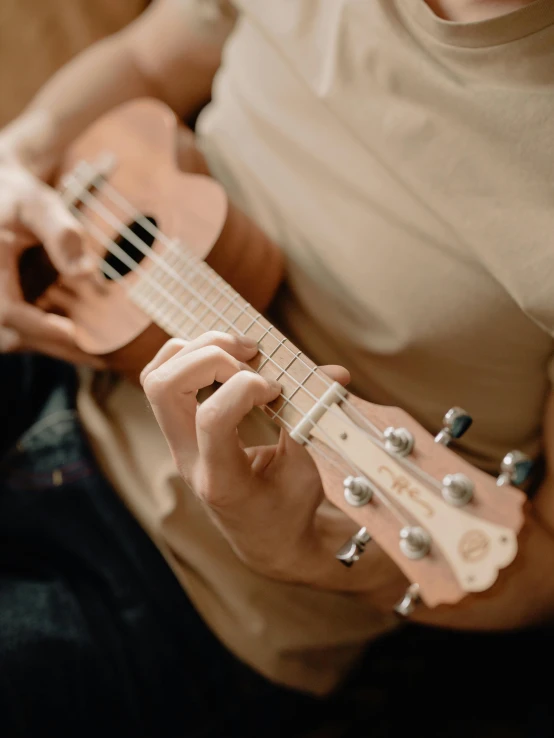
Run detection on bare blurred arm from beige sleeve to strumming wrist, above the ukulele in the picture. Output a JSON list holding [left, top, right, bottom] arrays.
[[0, 0, 230, 179]]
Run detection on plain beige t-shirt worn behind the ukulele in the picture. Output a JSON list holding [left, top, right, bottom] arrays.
[[81, 0, 554, 693]]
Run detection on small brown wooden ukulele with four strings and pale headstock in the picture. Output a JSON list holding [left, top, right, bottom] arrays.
[[21, 100, 531, 616]]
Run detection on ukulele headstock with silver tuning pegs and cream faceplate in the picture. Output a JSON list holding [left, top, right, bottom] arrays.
[[304, 388, 531, 615]]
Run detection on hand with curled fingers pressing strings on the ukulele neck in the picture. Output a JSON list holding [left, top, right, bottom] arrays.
[[141, 333, 351, 584]]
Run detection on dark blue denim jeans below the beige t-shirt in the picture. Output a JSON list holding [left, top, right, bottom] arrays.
[[0, 356, 319, 738]]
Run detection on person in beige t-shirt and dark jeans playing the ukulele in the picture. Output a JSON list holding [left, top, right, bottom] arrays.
[[0, 0, 554, 736]]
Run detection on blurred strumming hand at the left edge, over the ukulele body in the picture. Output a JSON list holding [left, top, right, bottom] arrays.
[[0, 144, 100, 366]]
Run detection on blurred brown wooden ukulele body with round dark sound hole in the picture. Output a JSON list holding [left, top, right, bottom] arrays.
[[29, 100, 283, 379]]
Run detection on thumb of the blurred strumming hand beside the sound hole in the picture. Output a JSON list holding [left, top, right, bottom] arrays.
[[19, 180, 95, 276]]
